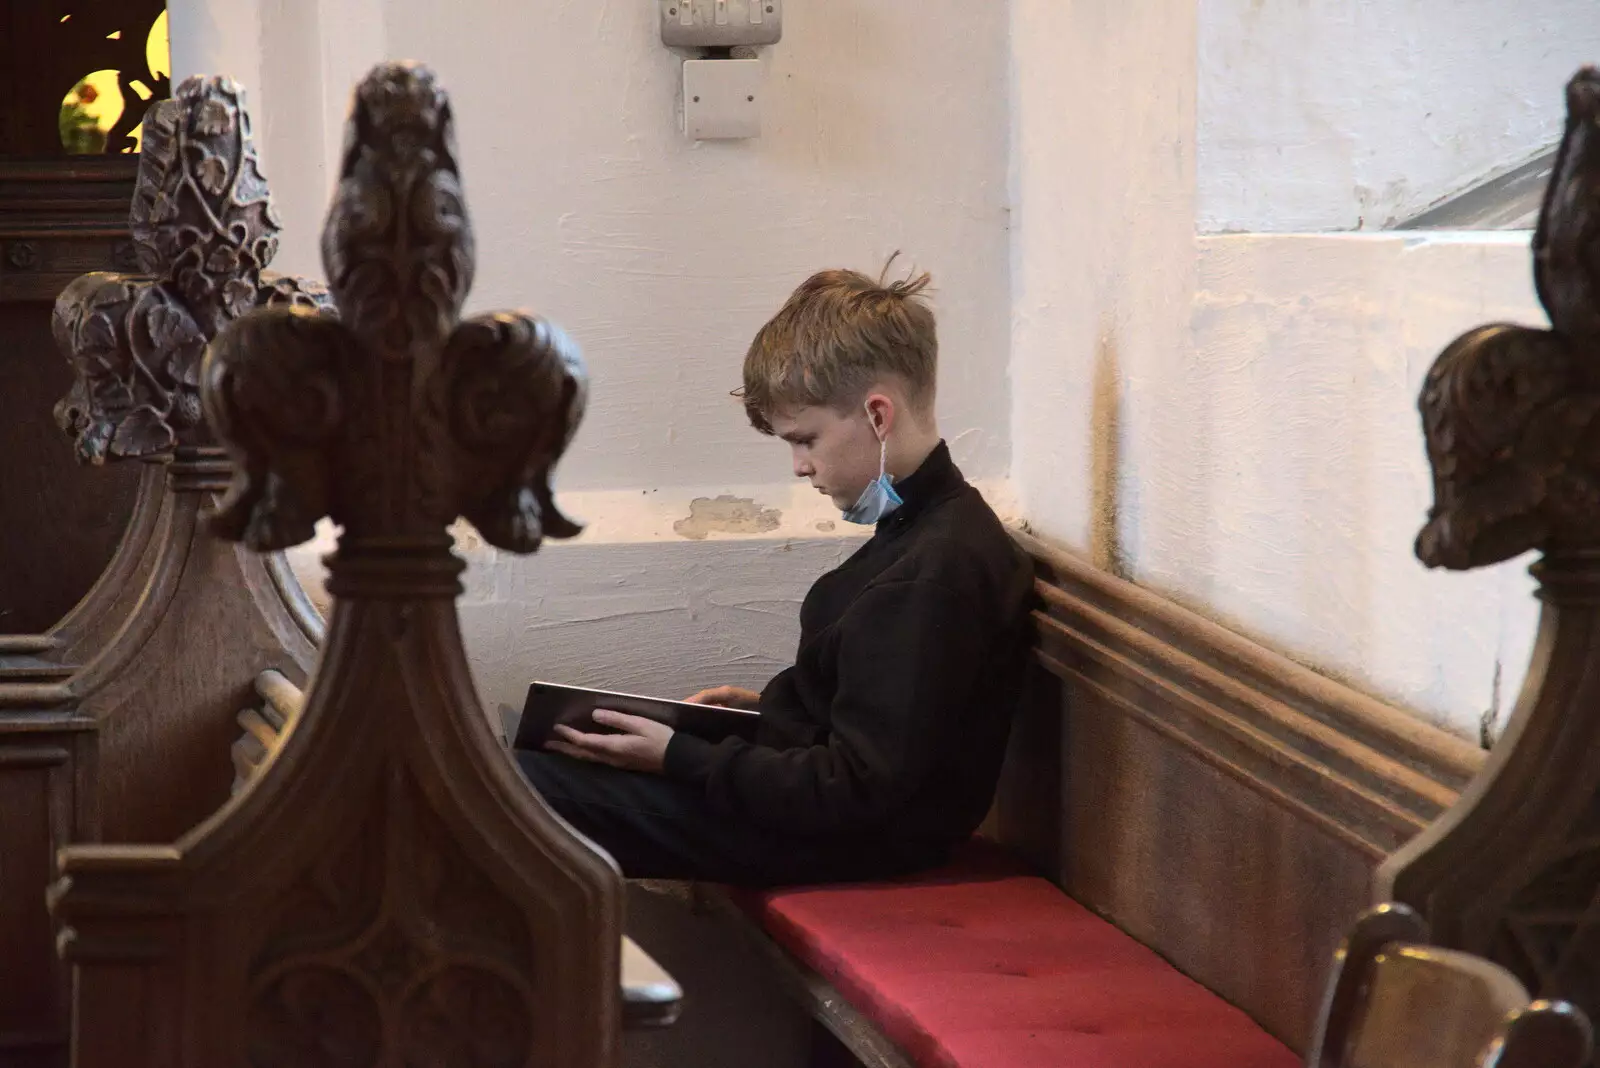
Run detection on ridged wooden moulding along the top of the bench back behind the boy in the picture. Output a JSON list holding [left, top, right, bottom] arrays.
[[1014, 531, 1486, 860]]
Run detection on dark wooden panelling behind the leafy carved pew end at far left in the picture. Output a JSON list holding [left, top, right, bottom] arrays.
[[0, 0, 168, 633]]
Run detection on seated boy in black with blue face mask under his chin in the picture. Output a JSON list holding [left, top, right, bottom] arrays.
[[517, 262, 1032, 886]]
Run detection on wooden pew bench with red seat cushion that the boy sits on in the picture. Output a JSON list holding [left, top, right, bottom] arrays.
[[690, 532, 1482, 1068]]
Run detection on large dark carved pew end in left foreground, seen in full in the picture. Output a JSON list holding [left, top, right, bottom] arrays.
[[53, 64, 622, 1068]]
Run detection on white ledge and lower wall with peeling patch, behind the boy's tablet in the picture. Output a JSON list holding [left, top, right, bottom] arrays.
[[288, 480, 1019, 713]]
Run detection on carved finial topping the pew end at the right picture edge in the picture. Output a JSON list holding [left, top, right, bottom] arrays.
[[1416, 67, 1600, 569]]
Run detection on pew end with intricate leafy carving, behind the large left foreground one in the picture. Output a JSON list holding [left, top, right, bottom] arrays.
[[53, 77, 331, 841]]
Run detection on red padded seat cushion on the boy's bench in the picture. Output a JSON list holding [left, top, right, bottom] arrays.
[[738, 851, 1301, 1068]]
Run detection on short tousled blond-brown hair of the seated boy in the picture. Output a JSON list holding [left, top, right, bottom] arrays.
[[734, 253, 939, 433]]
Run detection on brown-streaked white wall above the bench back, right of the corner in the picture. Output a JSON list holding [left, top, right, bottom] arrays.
[[1013, 0, 1542, 739]]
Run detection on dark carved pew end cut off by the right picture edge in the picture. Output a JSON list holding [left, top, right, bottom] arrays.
[[1376, 69, 1600, 1036]]
